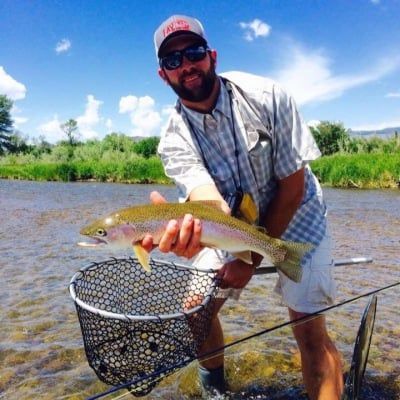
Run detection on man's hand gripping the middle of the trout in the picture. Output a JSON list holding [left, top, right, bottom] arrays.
[[142, 192, 202, 258]]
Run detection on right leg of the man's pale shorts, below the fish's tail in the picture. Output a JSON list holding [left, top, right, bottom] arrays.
[[275, 230, 336, 314]]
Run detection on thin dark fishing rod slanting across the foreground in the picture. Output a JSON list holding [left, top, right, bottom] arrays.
[[87, 281, 400, 400]]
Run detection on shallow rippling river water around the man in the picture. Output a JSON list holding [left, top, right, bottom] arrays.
[[0, 180, 400, 400]]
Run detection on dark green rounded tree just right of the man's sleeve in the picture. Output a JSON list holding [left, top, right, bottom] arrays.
[[311, 121, 350, 156]]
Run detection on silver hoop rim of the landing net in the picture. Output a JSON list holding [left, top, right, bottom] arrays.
[[69, 257, 217, 322]]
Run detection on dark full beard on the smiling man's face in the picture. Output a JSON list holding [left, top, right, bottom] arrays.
[[168, 60, 217, 103]]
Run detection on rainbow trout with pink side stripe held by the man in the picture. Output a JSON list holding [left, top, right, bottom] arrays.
[[78, 201, 313, 282]]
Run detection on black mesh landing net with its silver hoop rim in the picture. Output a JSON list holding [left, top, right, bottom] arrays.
[[70, 258, 217, 396]]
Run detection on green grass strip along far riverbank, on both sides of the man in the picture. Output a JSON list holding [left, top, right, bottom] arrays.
[[0, 152, 400, 189]]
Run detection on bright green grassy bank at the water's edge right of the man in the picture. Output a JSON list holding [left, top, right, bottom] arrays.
[[312, 152, 400, 189]]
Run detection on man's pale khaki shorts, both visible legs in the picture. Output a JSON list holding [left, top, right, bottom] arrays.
[[193, 229, 336, 314]]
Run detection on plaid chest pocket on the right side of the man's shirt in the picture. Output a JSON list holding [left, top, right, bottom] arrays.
[[249, 135, 273, 191]]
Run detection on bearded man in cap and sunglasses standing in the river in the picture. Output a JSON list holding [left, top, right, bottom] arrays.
[[143, 15, 343, 400]]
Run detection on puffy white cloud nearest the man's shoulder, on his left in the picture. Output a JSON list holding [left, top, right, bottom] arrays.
[[119, 95, 161, 136]]
